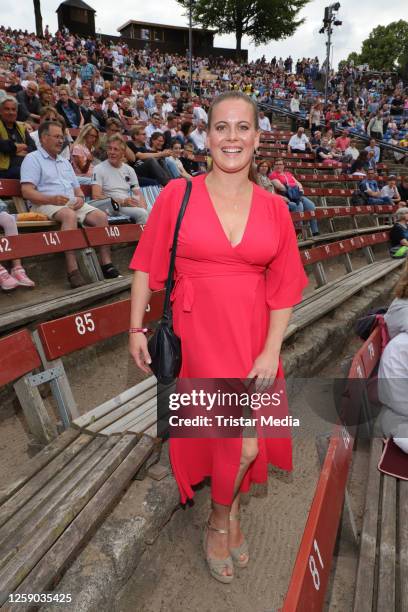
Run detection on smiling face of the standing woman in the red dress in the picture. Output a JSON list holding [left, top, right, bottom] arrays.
[[207, 98, 259, 173]]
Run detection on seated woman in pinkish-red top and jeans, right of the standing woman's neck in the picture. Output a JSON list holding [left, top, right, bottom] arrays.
[[269, 159, 319, 236]]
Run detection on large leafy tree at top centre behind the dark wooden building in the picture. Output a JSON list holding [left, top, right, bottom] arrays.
[[177, 0, 310, 52]]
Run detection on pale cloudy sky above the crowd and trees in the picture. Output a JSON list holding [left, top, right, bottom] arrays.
[[0, 0, 407, 66]]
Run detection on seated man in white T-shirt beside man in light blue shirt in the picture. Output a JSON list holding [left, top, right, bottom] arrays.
[[92, 134, 150, 225]]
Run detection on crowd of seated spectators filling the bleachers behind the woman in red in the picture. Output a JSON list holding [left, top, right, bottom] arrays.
[[0, 22, 408, 290]]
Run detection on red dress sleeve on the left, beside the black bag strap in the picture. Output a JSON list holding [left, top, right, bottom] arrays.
[[129, 179, 185, 291]]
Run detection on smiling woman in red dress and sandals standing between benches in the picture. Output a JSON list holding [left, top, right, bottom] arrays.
[[130, 92, 307, 583]]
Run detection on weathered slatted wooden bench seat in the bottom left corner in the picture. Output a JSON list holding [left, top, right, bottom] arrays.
[[0, 429, 155, 610]]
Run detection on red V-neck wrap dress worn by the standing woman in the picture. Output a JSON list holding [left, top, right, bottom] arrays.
[[130, 175, 307, 505]]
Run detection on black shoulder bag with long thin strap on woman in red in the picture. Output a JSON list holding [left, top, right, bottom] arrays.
[[147, 180, 191, 385]]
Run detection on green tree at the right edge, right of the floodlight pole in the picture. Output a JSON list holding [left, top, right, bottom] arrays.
[[360, 19, 408, 71]]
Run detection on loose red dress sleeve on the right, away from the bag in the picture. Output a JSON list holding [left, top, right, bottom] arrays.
[[266, 198, 308, 310]]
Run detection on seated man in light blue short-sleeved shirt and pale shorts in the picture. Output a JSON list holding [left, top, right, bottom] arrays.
[[21, 121, 119, 288]]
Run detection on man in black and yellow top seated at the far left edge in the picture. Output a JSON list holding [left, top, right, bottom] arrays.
[[0, 96, 36, 179]]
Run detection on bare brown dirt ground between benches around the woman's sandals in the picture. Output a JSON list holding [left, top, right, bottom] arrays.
[[115, 340, 367, 612]]
